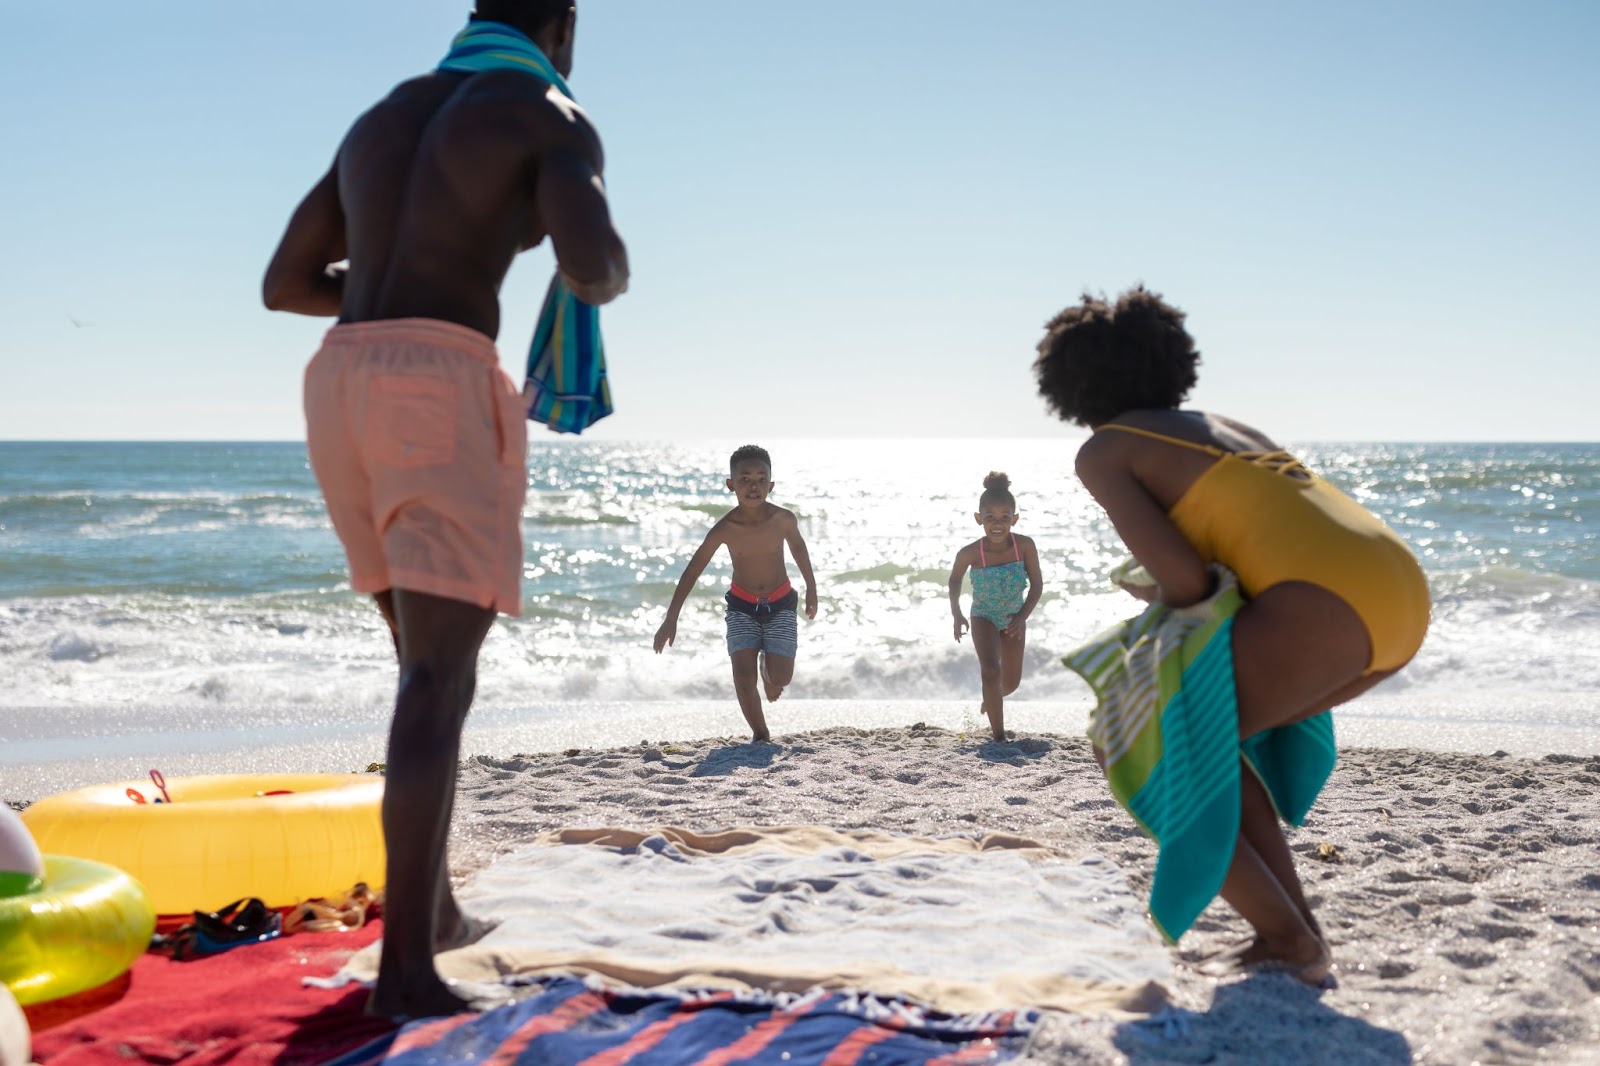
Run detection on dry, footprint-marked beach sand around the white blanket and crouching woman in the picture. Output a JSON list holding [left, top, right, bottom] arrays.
[[451, 727, 1600, 1064]]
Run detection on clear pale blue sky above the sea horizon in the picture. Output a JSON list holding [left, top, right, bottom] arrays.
[[0, 0, 1600, 440]]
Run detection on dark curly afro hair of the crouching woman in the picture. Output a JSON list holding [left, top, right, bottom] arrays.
[[1034, 285, 1200, 426]]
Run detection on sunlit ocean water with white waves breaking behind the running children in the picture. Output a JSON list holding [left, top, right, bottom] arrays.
[[0, 439, 1600, 795]]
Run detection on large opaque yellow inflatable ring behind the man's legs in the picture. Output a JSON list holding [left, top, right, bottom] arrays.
[[22, 773, 384, 914]]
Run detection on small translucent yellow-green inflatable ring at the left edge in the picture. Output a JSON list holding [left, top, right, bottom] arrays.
[[0, 855, 155, 1007]]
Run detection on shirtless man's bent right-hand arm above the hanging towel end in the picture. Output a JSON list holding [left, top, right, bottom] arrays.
[[536, 120, 627, 306]]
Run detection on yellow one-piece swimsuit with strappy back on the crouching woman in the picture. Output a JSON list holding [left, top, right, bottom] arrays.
[[1101, 426, 1429, 674]]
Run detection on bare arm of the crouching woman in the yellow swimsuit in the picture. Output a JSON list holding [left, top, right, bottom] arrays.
[[1077, 434, 1211, 607]]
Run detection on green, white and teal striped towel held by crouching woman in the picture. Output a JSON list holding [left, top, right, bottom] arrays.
[[1061, 560, 1336, 940]]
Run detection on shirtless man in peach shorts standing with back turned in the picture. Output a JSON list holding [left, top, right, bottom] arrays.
[[262, 0, 627, 1018]]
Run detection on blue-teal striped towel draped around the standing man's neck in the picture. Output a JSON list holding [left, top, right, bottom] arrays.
[[438, 21, 611, 434]]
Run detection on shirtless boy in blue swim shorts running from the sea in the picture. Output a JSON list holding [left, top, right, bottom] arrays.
[[656, 445, 816, 741]]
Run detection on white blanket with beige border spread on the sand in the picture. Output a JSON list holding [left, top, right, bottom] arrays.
[[342, 826, 1170, 1015]]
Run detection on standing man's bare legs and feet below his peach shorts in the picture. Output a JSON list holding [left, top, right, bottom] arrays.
[[368, 589, 494, 1018]]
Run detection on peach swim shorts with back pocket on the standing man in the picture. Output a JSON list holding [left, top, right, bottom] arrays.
[[306, 319, 528, 615]]
